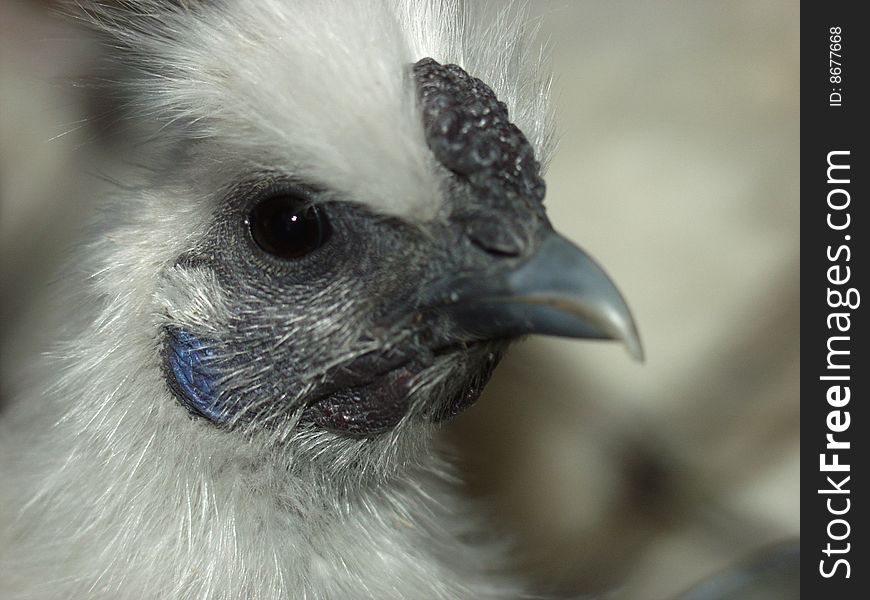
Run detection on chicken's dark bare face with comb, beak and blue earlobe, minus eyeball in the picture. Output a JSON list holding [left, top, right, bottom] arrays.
[[164, 59, 641, 436]]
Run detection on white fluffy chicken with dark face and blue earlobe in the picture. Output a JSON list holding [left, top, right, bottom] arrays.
[[0, 0, 642, 600]]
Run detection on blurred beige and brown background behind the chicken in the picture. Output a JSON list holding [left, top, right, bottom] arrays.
[[0, 0, 800, 600]]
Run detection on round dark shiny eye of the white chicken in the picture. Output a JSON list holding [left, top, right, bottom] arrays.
[[248, 194, 331, 259]]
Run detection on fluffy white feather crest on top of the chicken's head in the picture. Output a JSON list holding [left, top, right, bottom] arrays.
[[73, 0, 552, 220]]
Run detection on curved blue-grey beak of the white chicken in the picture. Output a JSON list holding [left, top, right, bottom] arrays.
[[430, 231, 643, 361]]
